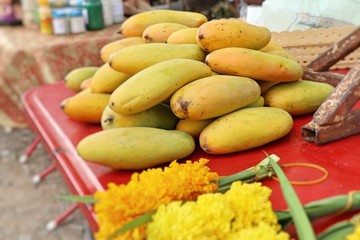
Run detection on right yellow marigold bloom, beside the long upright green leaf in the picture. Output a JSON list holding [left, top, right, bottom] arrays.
[[225, 181, 281, 230]]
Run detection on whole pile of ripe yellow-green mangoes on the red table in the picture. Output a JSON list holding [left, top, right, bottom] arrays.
[[61, 10, 333, 170]]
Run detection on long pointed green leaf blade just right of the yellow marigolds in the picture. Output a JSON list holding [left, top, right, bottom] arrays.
[[268, 156, 316, 240]]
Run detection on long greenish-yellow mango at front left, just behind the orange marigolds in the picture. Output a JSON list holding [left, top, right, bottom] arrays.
[[77, 127, 195, 170]]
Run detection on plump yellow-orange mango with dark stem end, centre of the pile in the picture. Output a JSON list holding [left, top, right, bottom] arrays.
[[170, 75, 260, 120]]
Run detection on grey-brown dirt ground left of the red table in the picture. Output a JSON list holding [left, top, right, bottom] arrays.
[[0, 127, 93, 240]]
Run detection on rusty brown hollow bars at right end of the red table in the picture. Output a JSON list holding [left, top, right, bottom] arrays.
[[301, 27, 360, 145]]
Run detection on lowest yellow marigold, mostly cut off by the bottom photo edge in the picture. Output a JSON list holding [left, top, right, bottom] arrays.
[[226, 223, 290, 240]]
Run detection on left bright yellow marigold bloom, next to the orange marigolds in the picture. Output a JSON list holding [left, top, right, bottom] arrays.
[[147, 194, 235, 240]]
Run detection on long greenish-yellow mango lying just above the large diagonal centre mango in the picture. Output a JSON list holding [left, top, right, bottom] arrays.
[[109, 43, 206, 74]]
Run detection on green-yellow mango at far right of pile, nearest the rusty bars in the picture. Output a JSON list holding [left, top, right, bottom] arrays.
[[264, 80, 334, 116]]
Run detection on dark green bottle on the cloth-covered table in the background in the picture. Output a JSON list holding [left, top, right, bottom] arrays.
[[83, 0, 105, 30]]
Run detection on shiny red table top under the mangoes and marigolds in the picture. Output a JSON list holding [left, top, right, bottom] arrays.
[[22, 82, 360, 233]]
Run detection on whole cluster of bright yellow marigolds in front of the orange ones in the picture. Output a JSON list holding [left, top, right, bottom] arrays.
[[146, 182, 289, 240]]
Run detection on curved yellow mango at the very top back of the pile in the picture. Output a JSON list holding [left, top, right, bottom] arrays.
[[119, 9, 207, 37]]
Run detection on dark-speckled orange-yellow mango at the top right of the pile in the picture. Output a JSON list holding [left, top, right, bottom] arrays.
[[196, 18, 271, 52]]
